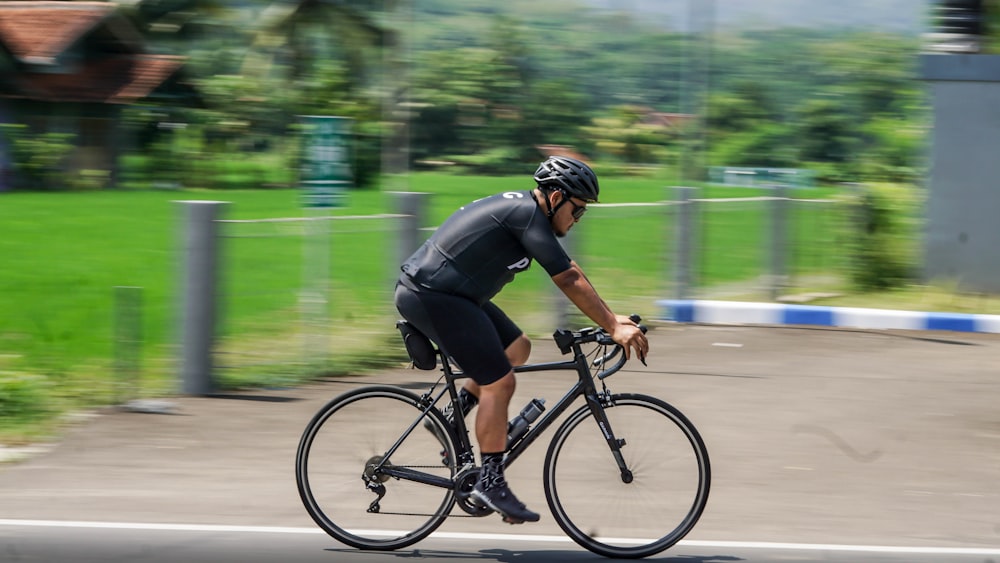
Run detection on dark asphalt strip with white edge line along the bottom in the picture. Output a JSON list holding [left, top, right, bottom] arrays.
[[0, 525, 1000, 563]]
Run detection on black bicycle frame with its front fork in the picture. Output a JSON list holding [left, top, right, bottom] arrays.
[[375, 333, 631, 488]]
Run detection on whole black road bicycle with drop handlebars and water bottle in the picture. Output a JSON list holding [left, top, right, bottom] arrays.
[[295, 316, 711, 558]]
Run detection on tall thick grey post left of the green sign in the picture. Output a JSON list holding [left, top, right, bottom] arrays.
[[177, 201, 227, 395]]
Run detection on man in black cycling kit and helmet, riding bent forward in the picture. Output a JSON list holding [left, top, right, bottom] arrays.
[[395, 156, 649, 524]]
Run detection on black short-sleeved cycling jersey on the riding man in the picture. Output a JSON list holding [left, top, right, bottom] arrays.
[[401, 191, 570, 304]]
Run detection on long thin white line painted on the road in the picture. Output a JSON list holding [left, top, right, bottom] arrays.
[[0, 519, 1000, 556]]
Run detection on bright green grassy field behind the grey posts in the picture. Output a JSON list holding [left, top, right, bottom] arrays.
[[0, 174, 872, 441]]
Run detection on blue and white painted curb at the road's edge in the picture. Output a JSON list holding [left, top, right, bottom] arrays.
[[657, 299, 1000, 333]]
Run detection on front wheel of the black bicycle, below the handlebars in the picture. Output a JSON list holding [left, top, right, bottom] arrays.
[[544, 394, 711, 558]]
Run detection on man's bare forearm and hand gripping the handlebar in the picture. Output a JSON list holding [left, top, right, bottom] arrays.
[[552, 261, 649, 359]]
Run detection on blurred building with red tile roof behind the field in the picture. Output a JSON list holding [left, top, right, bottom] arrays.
[[0, 1, 197, 189]]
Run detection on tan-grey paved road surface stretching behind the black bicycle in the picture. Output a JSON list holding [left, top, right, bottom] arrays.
[[0, 326, 1000, 562]]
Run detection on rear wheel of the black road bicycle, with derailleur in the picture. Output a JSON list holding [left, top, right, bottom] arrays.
[[295, 386, 455, 550]]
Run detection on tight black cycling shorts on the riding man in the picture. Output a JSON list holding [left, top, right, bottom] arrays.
[[396, 283, 522, 385]]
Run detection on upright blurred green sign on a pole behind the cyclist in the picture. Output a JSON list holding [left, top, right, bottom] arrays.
[[299, 115, 354, 207]]
